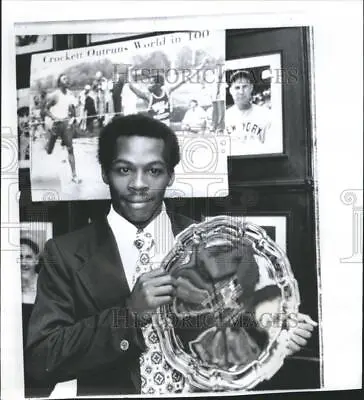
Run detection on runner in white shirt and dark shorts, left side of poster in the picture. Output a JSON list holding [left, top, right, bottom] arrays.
[[46, 74, 81, 183]]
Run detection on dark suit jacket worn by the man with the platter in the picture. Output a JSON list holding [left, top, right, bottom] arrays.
[[25, 213, 193, 395]]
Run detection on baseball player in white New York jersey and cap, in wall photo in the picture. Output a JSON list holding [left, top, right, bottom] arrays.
[[225, 71, 271, 153]]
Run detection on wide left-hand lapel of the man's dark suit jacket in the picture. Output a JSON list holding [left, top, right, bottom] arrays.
[[77, 219, 130, 310]]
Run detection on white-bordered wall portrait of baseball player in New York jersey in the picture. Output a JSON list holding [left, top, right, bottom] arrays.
[[225, 53, 284, 156]]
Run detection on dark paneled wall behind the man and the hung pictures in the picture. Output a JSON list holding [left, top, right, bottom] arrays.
[[16, 28, 320, 390]]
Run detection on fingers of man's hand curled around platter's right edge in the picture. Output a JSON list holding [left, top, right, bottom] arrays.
[[287, 313, 318, 355]]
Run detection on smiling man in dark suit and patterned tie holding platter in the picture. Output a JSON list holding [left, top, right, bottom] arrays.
[[25, 115, 311, 395]]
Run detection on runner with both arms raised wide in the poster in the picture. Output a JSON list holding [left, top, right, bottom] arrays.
[[128, 58, 207, 126]]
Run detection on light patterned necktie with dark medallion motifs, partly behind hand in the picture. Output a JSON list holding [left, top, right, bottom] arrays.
[[133, 230, 184, 395]]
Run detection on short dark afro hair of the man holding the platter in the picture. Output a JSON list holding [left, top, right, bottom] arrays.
[[98, 114, 180, 173]]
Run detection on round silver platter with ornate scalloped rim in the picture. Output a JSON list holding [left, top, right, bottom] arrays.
[[153, 216, 300, 391]]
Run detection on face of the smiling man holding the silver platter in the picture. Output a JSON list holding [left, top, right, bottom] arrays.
[[103, 136, 174, 226]]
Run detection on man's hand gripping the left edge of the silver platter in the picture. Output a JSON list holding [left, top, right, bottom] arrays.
[[127, 268, 176, 318]]
